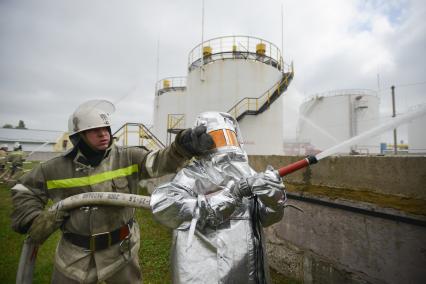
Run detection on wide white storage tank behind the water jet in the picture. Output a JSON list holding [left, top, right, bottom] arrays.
[[297, 90, 380, 154]]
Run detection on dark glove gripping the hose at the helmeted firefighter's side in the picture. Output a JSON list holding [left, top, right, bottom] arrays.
[[28, 210, 69, 245]]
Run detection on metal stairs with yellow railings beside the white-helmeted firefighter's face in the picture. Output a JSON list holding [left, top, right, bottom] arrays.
[[112, 122, 165, 150]]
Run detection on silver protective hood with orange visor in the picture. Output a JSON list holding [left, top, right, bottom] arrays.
[[195, 111, 245, 153]]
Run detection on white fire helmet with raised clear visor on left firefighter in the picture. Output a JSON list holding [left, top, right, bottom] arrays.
[[68, 100, 115, 137]]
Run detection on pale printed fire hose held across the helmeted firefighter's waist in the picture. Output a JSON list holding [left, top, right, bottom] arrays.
[[16, 192, 151, 284]]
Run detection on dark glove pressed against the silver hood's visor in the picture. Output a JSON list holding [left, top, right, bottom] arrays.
[[179, 125, 214, 156]]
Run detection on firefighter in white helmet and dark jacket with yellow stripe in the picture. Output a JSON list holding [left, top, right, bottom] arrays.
[[11, 100, 213, 284]]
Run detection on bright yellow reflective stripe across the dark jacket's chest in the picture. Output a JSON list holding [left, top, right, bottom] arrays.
[[47, 164, 138, 189]]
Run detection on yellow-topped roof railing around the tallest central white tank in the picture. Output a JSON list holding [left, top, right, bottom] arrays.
[[188, 35, 290, 73]]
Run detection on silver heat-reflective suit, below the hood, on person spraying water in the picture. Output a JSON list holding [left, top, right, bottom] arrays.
[[151, 111, 285, 283]]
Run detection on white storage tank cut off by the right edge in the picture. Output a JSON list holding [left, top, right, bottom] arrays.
[[407, 105, 426, 154]]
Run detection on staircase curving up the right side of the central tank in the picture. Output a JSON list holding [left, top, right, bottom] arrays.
[[227, 64, 294, 121]]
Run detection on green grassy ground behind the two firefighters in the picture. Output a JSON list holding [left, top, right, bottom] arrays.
[[0, 165, 297, 284]]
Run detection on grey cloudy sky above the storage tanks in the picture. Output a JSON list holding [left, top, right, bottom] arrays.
[[0, 0, 426, 141]]
